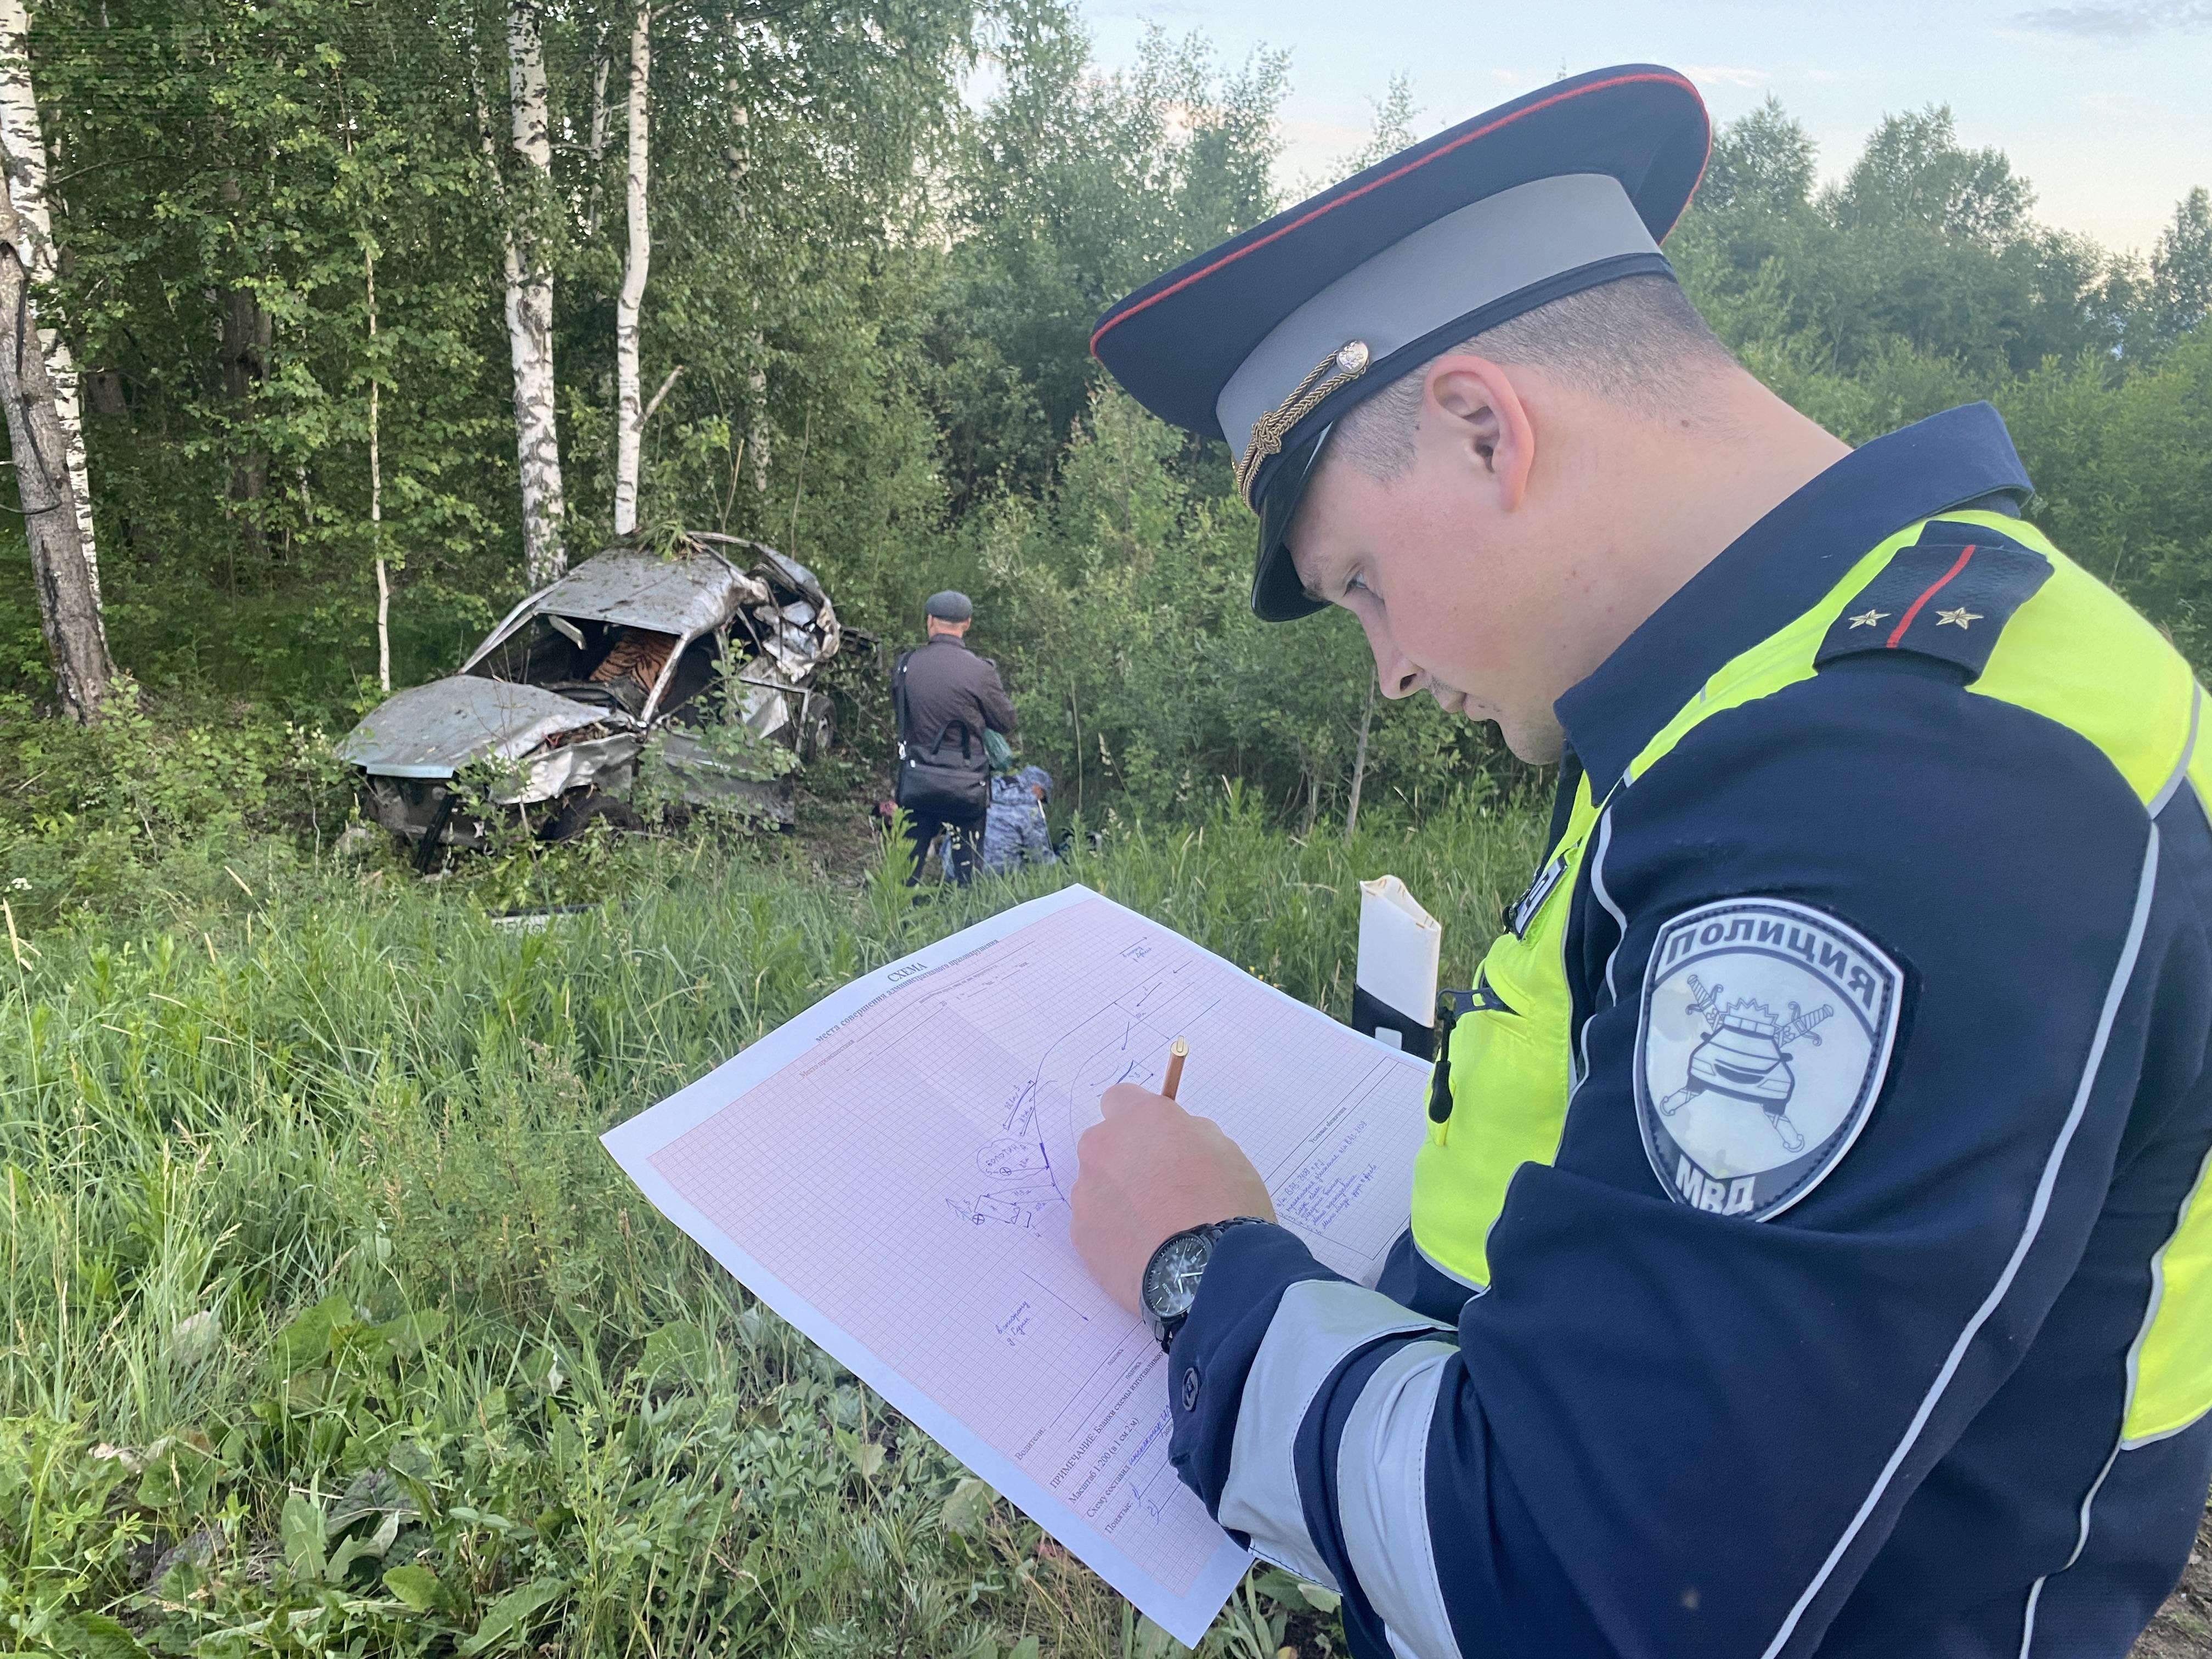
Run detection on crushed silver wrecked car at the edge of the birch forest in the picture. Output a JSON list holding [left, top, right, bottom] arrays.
[[338, 531, 843, 870]]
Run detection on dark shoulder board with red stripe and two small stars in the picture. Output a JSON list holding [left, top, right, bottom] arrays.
[[1814, 520, 2051, 684]]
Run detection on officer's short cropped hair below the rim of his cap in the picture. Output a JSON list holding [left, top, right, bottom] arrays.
[[1329, 276, 1736, 482]]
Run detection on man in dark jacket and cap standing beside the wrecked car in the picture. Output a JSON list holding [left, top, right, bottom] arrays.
[[891, 591, 1013, 887]]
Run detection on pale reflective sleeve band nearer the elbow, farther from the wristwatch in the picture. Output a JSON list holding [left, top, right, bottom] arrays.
[[1336, 1342, 1460, 1659]]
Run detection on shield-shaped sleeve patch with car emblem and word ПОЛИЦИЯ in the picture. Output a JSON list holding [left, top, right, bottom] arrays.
[[1635, 898, 1903, 1221]]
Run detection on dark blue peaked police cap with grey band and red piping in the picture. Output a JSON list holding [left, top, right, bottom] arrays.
[[1091, 64, 1712, 622]]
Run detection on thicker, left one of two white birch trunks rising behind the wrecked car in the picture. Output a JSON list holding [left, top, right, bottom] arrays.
[[504, 0, 568, 589]]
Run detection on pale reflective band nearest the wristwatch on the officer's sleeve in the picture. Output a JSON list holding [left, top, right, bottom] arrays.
[[1217, 1278, 1449, 1588]]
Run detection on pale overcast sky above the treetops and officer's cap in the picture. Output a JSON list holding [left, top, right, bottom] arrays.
[[1082, 0, 2212, 252]]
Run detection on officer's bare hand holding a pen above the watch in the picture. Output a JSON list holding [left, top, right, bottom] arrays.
[[1068, 1084, 1274, 1314]]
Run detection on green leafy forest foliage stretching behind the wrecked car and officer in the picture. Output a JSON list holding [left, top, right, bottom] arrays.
[[0, 0, 2212, 832]]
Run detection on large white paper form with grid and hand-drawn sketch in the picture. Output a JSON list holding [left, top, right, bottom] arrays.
[[604, 887, 1427, 1646]]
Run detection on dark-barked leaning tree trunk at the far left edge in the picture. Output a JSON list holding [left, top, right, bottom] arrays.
[[0, 163, 115, 721]]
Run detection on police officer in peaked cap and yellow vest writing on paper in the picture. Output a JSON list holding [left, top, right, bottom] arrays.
[[1070, 66, 2212, 1659]]
